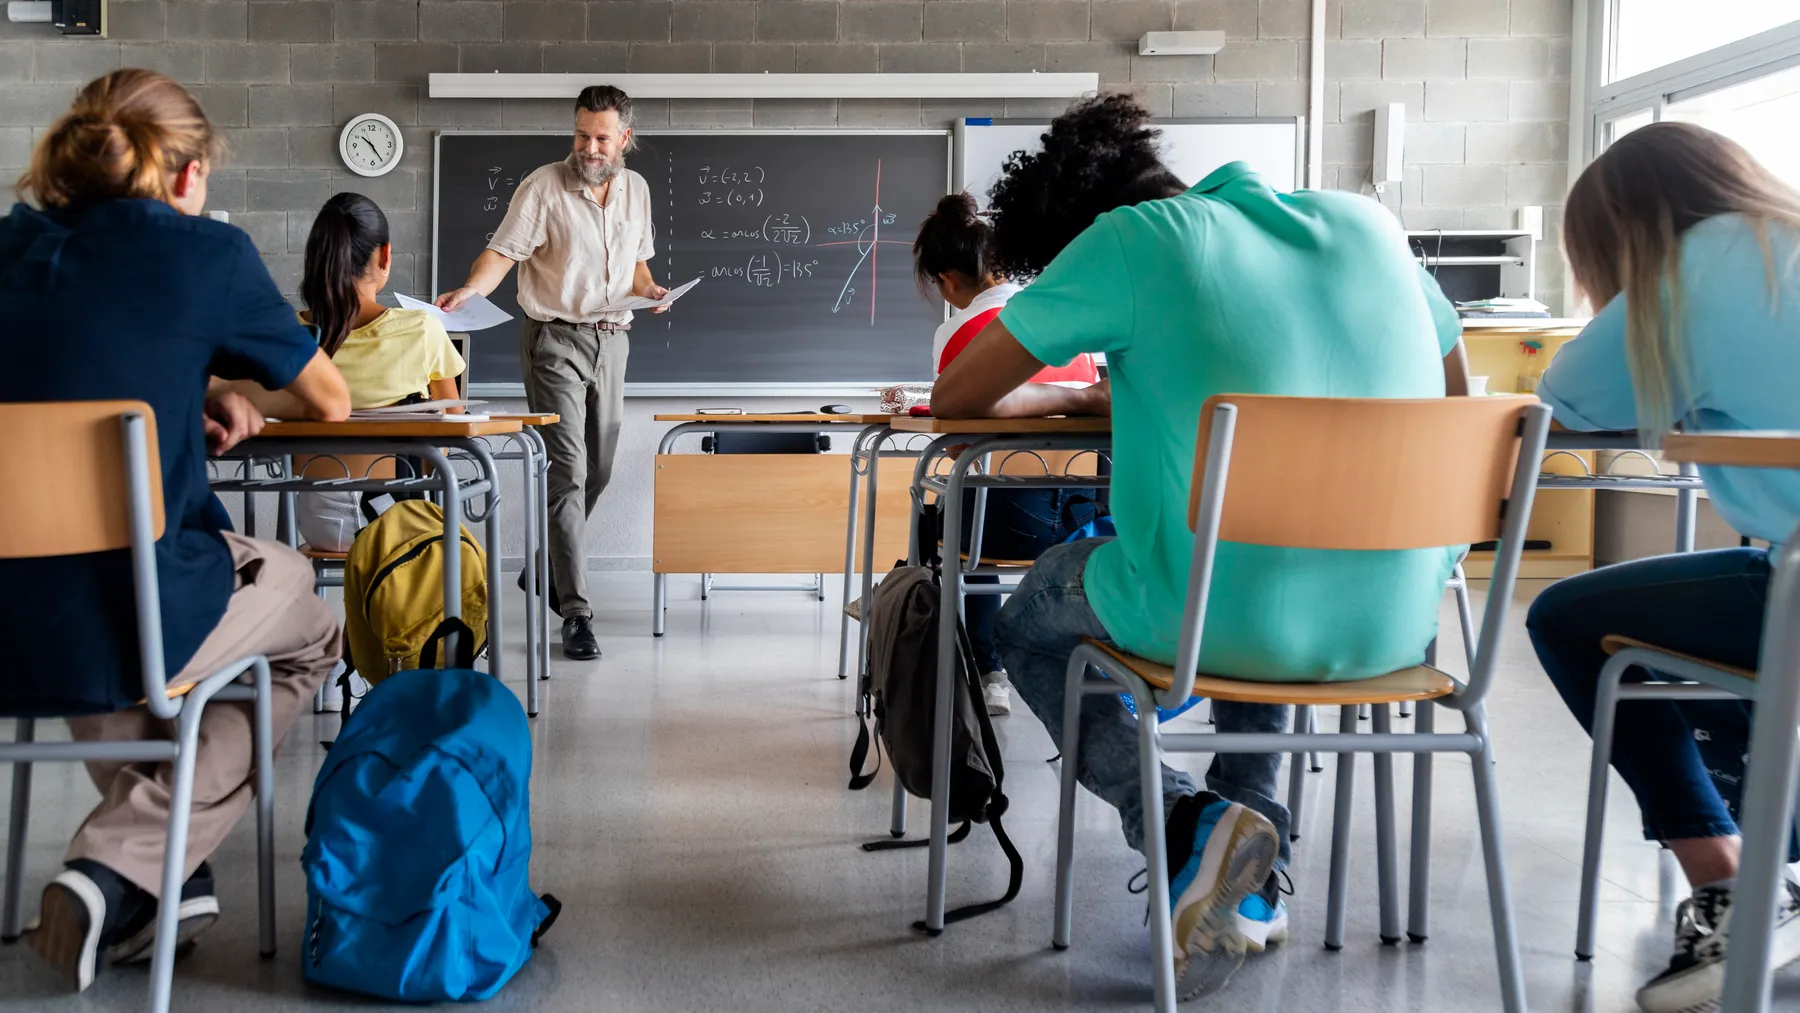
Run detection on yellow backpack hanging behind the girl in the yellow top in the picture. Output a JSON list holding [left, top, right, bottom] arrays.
[[344, 500, 488, 684]]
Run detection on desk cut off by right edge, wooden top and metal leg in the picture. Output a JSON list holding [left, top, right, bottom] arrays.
[[1663, 432, 1800, 1013]]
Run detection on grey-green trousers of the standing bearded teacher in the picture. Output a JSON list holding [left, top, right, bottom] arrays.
[[518, 318, 632, 619]]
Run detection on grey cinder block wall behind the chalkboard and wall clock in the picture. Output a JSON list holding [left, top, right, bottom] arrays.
[[0, 0, 1571, 569]]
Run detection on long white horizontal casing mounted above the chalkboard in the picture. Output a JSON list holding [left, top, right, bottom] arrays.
[[430, 72, 1094, 99]]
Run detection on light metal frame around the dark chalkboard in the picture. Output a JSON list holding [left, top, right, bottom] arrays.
[[432, 126, 958, 398]]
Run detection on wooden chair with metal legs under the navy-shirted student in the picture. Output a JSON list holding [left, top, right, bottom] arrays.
[[0, 401, 275, 1013]]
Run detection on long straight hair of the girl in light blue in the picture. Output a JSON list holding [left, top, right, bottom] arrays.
[[1562, 122, 1800, 434]]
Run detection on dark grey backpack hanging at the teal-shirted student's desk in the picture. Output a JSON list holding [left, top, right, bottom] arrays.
[[850, 567, 1024, 930]]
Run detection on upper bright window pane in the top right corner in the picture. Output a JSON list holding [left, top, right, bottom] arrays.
[[1607, 0, 1800, 81]]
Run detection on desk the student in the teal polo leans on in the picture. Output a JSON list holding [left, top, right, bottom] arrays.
[[864, 416, 1112, 936]]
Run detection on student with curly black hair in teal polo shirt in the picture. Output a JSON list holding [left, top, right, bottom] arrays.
[[932, 95, 1465, 999]]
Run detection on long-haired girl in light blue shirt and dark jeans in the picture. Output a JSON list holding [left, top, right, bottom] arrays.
[[1526, 122, 1800, 1013]]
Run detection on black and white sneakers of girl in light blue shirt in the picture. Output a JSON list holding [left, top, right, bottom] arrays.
[[1638, 880, 1800, 1013]]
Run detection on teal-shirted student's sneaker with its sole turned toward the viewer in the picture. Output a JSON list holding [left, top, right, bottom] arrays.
[[1166, 792, 1285, 1000]]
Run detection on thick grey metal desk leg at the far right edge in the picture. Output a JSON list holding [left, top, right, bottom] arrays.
[[1721, 529, 1800, 1013]]
